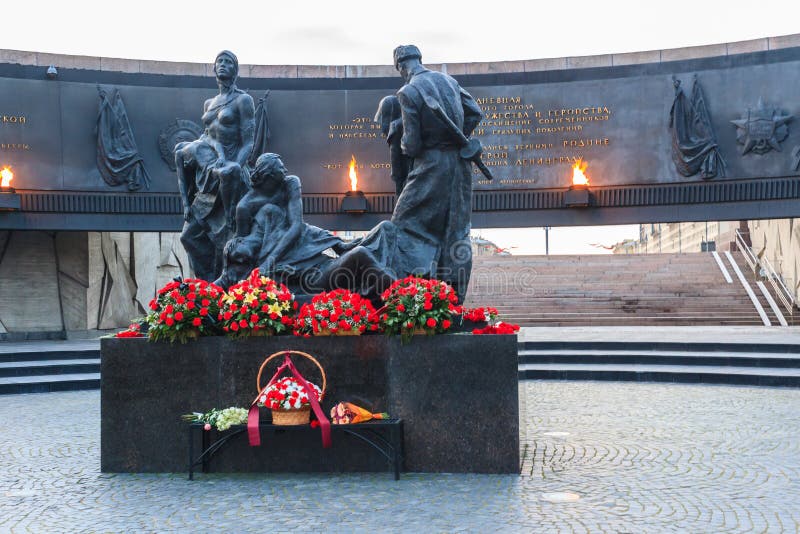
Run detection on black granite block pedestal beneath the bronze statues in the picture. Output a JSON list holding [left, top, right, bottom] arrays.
[[101, 334, 519, 473]]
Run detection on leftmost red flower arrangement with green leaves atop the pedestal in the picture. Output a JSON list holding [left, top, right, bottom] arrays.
[[147, 277, 223, 343]]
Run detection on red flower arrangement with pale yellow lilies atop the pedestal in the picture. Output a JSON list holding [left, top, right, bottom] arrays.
[[218, 269, 297, 337]]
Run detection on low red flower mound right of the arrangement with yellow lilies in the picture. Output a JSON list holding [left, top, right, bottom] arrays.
[[294, 289, 379, 337]]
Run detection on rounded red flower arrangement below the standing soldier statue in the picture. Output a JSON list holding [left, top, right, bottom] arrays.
[[380, 276, 458, 339]]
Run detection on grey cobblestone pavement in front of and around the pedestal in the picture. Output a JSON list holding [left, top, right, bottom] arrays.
[[0, 381, 800, 532]]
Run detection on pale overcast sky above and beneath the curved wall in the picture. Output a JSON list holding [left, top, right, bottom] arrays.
[[0, 0, 800, 254]]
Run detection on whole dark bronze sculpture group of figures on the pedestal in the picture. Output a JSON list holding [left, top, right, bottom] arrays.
[[175, 45, 488, 299]]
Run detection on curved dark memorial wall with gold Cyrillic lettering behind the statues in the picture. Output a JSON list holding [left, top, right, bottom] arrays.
[[0, 31, 800, 231]]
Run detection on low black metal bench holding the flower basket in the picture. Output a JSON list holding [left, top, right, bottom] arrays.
[[189, 419, 403, 480]]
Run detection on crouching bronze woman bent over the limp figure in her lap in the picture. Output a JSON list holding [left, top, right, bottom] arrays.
[[215, 153, 345, 290]]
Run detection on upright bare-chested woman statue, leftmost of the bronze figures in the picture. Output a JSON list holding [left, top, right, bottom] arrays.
[[175, 50, 255, 280]]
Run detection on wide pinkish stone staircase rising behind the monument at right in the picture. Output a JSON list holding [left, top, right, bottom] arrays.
[[466, 252, 792, 326]]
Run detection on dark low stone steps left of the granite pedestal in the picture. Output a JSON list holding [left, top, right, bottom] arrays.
[[0, 340, 100, 394]]
